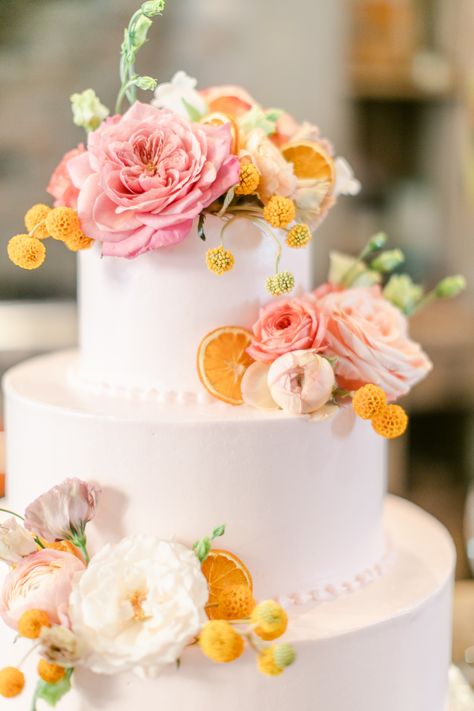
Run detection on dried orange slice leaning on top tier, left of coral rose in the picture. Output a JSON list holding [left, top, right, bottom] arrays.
[[197, 326, 253, 405]]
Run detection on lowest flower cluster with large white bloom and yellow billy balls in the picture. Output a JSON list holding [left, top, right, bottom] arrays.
[[0, 479, 296, 709]]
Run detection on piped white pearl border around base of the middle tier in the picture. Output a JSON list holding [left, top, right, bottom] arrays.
[[277, 538, 395, 608]]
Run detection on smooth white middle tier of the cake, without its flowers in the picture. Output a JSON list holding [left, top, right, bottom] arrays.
[[4, 353, 385, 601]]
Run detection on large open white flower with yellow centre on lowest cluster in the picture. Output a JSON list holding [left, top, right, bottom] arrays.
[[70, 536, 208, 677]]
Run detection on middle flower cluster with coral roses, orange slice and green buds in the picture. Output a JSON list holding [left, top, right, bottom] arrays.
[[198, 233, 465, 439]]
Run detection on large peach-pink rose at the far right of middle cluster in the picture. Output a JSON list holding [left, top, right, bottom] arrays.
[[317, 287, 432, 400]]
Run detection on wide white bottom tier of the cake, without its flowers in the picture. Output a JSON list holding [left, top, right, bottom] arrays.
[[0, 497, 455, 711]]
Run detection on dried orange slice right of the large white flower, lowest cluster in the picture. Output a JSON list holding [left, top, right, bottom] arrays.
[[202, 548, 253, 620]]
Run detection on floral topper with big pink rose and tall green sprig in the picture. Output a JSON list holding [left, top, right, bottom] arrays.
[[8, 0, 360, 296]]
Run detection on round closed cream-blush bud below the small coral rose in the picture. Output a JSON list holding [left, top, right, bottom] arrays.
[[267, 349, 336, 415]]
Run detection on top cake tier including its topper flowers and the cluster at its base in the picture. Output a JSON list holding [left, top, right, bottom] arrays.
[[8, 0, 464, 422]]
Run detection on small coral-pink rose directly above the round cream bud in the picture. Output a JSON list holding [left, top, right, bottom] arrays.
[[248, 298, 326, 363]]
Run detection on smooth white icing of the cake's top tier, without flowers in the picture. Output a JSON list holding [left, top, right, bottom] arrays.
[[79, 218, 310, 394]]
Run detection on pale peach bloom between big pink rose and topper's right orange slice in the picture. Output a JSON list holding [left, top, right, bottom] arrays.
[[244, 128, 298, 202]]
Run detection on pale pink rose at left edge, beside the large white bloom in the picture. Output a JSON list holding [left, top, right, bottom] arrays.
[[0, 549, 85, 629]]
